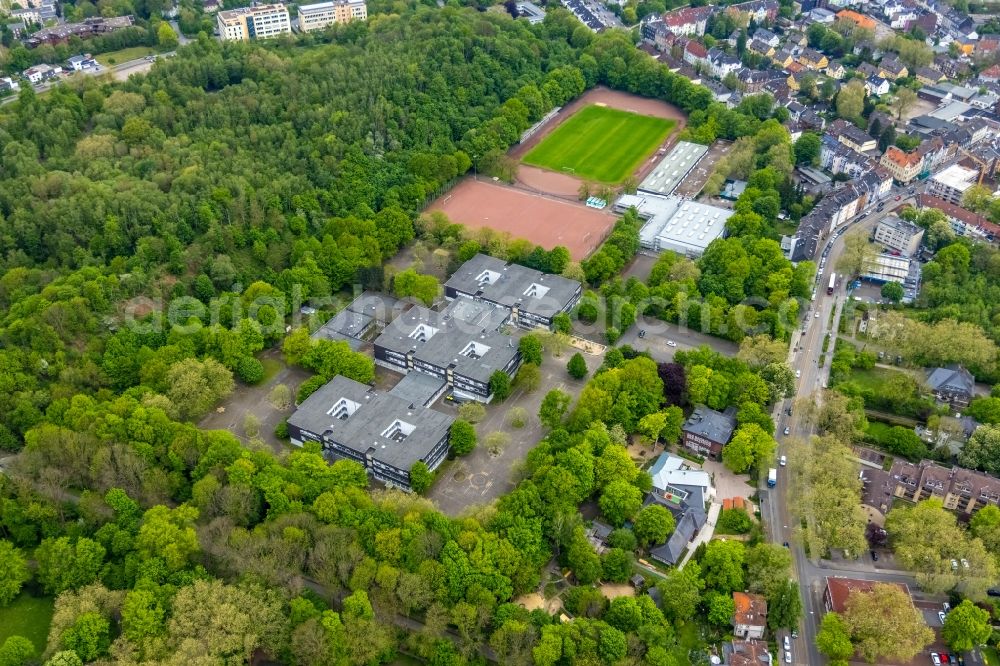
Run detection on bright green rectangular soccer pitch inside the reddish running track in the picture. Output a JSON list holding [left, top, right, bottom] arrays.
[[523, 105, 677, 183]]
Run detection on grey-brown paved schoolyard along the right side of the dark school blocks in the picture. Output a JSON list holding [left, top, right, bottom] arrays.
[[427, 350, 603, 516]]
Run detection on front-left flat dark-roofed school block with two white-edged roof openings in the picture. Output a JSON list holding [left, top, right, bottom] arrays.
[[288, 375, 455, 490]]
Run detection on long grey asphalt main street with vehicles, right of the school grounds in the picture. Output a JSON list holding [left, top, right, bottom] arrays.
[[761, 183, 919, 666]]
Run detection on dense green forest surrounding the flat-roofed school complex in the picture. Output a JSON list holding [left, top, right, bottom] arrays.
[[0, 2, 809, 665]]
